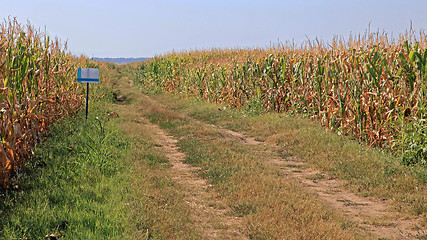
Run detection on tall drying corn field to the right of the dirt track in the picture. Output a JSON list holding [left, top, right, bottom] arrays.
[[139, 30, 427, 165]]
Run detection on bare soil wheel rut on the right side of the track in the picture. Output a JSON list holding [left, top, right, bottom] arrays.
[[219, 125, 426, 239]]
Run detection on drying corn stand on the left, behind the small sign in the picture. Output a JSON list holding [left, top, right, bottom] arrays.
[[0, 19, 86, 187]]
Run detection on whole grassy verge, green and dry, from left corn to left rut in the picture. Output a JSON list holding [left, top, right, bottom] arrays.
[[0, 59, 200, 239]]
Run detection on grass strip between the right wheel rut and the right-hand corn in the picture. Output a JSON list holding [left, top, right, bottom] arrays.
[[155, 95, 427, 219]]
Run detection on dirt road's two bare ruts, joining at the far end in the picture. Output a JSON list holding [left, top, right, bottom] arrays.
[[109, 68, 424, 239]]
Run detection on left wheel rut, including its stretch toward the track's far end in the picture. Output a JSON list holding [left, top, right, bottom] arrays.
[[115, 78, 248, 239]]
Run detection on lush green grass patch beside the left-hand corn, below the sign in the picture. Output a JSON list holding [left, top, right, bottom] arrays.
[[0, 92, 131, 239]]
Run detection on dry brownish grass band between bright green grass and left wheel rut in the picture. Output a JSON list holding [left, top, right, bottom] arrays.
[[101, 63, 200, 239]]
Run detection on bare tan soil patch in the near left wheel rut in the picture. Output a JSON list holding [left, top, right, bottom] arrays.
[[134, 115, 247, 239]]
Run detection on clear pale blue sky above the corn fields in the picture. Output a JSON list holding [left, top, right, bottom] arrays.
[[0, 0, 427, 57]]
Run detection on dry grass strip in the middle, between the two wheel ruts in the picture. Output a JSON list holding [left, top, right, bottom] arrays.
[[137, 95, 366, 239]]
